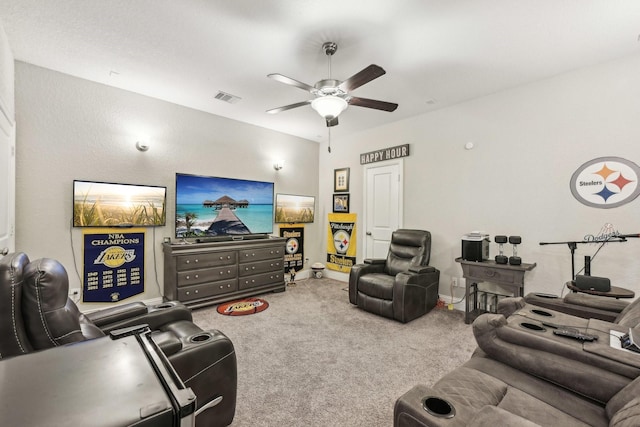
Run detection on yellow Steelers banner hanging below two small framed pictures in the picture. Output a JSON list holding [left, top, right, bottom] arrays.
[[327, 213, 356, 273]]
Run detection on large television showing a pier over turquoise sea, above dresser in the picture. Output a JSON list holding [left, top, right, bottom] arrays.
[[176, 173, 273, 238]]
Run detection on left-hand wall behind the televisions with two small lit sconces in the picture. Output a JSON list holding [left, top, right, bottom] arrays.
[[16, 62, 323, 309]]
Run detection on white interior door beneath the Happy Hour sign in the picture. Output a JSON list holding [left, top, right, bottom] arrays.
[[364, 159, 403, 258]]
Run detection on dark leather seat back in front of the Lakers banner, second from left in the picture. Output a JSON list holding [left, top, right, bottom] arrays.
[[22, 258, 104, 350]]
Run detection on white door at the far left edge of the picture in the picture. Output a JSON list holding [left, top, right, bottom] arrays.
[[0, 100, 16, 257]]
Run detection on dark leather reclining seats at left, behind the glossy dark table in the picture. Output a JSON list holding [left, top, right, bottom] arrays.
[[0, 253, 237, 426]]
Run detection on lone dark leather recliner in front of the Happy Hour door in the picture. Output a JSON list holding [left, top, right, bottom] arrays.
[[349, 229, 440, 323]]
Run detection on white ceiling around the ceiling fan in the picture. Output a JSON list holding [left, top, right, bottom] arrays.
[[0, 0, 640, 141]]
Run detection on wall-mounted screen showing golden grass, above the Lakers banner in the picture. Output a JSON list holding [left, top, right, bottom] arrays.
[[73, 180, 167, 227]]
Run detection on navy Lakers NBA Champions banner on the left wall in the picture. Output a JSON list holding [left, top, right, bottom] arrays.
[[82, 228, 144, 302]]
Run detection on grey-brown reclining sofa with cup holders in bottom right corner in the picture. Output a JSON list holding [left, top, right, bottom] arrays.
[[394, 292, 640, 427]]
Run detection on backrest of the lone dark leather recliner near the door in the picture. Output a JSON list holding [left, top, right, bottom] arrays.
[[385, 229, 431, 276]]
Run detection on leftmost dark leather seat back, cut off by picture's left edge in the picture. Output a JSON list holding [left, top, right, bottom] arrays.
[[0, 252, 33, 359]]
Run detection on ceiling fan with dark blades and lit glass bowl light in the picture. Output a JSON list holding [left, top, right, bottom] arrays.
[[267, 42, 398, 127]]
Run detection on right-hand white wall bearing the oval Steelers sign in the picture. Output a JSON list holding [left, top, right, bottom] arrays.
[[320, 51, 640, 297]]
